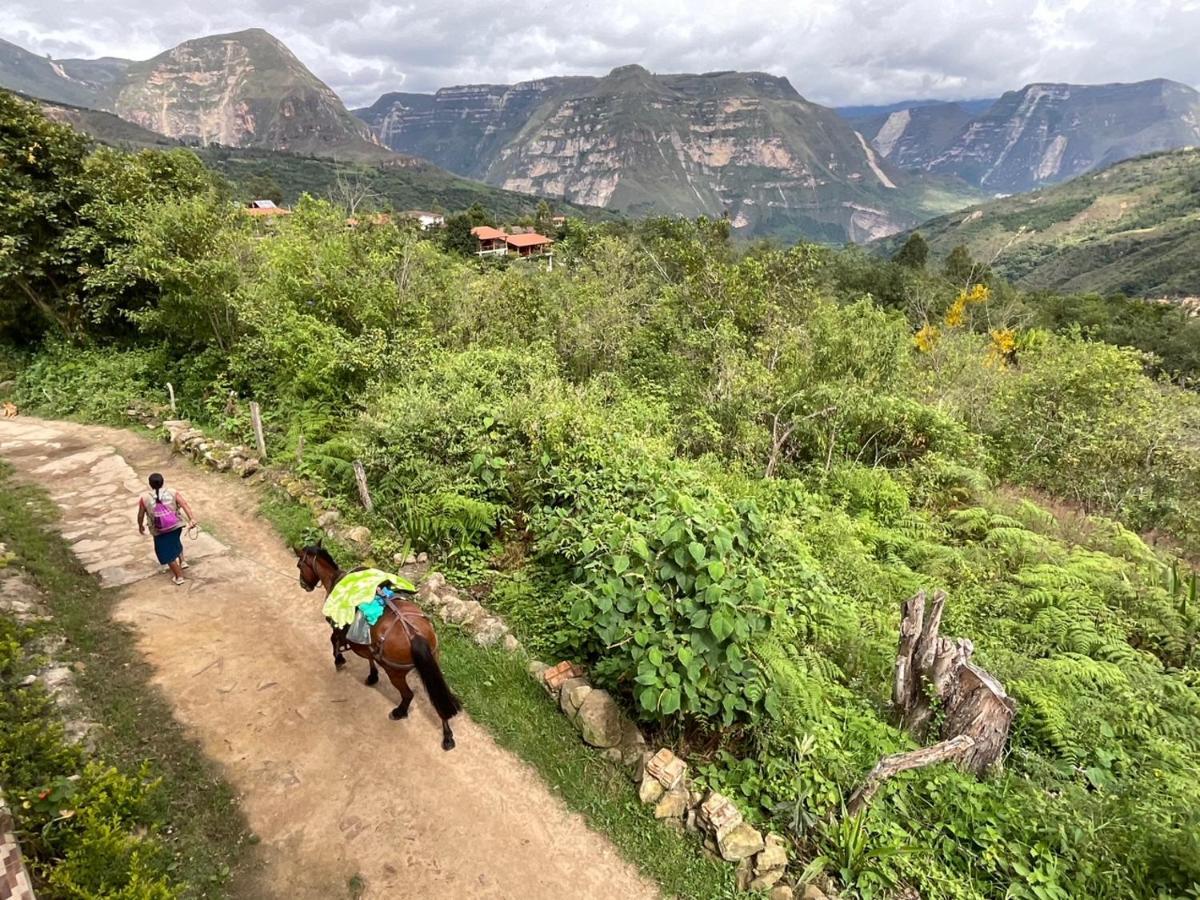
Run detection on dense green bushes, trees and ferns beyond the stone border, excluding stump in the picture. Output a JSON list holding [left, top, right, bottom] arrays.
[[7, 91, 1200, 899]]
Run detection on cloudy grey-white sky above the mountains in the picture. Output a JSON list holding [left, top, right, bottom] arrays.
[[0, 0, 1200, 106]]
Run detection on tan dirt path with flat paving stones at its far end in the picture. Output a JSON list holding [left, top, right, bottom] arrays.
[[0, 418, 658, 900]]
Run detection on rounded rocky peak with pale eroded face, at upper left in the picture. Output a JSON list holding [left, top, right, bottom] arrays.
[[114, 29, 374, 152]]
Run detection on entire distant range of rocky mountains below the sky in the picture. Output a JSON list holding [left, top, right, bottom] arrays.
[[0, 29, 1200, 242]]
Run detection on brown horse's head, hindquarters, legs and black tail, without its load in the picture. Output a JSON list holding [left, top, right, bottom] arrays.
[[295, 545, 462, 750]]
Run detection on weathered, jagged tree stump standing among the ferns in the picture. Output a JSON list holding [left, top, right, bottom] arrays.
[[892, 590, 1016, 774]]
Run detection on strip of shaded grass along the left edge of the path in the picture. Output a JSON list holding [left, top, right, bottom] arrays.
[[0, 463, 254, 898]]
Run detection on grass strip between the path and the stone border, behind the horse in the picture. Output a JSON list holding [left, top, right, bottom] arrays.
[[260, 491, 738, 900]]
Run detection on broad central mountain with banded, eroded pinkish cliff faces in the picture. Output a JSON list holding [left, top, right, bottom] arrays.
[[359, 66, 912, 240]]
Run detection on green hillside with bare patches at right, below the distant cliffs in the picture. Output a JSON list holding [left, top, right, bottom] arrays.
[[878, 150, 1200, 296]]
